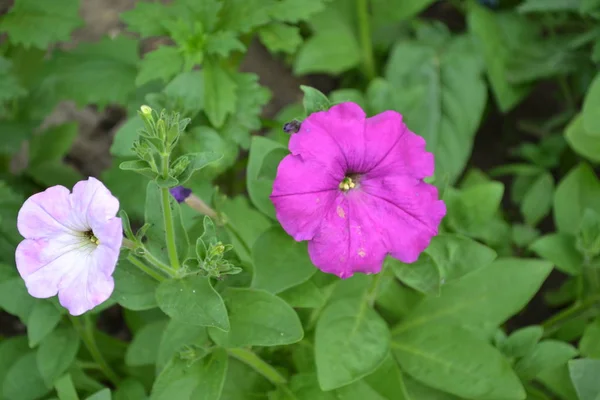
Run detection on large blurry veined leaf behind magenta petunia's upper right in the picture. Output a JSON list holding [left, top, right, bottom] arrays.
[[385, 33, 487, 183]]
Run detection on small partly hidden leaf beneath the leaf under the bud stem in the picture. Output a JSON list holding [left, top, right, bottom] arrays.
[[156, 319, 208, 371]]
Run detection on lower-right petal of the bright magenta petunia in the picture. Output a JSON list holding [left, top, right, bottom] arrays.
[[360, 176, 446, 263]]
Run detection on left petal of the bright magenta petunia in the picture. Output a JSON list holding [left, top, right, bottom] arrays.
[[271, 155, 343, 241]]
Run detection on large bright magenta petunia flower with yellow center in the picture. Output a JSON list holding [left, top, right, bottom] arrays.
[[271, 103, 446, 278]]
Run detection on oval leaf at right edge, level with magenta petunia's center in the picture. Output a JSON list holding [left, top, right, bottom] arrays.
[[554, 163, 600, 234]]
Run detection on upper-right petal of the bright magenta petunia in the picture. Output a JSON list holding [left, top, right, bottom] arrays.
[[363, 111, 434, 179]]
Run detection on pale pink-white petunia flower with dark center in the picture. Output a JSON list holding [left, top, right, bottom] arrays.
[[16, 178, 123, 315]]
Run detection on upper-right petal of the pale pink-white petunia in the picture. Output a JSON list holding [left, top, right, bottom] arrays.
[[71, 177, 119, 227]]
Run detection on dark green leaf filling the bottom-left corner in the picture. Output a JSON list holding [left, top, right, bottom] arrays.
[[3, 349, 51, 400]]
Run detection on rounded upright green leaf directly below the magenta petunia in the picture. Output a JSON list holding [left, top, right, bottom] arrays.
[[315, 299, 390, 390]]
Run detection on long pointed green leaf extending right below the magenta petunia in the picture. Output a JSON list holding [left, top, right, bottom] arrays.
[[394, 258, 552, 336]]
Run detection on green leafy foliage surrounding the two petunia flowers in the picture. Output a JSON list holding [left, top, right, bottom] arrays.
[[0, 0, 600, 400]]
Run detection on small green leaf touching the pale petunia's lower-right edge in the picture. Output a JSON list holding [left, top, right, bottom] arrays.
[[111, 260, 158, 311]]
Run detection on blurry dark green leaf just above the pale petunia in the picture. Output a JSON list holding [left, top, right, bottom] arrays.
[[29, 122, 78, 165]]
